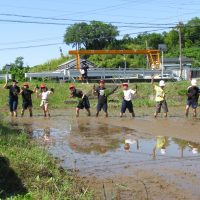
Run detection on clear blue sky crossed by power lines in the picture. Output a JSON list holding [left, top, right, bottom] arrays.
[[0, 0, 200, 68]]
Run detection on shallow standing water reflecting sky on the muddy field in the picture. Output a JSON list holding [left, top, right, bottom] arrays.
[[33, 122, 200, 177]]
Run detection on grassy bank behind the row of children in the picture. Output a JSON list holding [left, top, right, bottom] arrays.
[[0, 81, 190, 112]]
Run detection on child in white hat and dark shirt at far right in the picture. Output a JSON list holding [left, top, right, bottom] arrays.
[[185, 79, 199, 117]]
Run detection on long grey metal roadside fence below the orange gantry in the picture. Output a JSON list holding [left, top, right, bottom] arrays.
[[25, 68, 178, 81]]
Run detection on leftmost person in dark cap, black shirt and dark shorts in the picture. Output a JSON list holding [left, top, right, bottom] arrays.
[[4, 80, 20, 117]]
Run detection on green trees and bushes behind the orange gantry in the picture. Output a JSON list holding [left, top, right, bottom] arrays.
[[64, 17, 200, 67]]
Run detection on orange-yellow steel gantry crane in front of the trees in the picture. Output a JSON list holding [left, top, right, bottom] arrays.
[[69, 50, 160, 69]]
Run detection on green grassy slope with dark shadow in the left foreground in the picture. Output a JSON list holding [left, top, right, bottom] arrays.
[[0, 125, 93, 200]]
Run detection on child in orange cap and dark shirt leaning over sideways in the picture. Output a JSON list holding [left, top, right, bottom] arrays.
[[69, 84, 91, 117]]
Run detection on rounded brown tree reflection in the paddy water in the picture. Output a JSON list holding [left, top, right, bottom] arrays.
[[67, 119, 126, 154]]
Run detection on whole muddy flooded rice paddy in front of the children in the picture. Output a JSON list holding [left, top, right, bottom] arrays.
[[4, 107, 200, 200]]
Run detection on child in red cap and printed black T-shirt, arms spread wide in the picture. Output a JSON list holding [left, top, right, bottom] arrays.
[[93, 80, 118, 117]]
